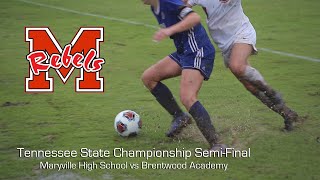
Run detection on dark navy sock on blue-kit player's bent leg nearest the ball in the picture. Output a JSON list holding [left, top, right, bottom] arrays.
[[151, 82, 183, 118]]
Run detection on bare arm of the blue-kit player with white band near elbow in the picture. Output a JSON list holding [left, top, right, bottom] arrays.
[[153, 6, 201, 41]]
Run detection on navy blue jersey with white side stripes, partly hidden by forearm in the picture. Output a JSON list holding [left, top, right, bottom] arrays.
[[151, 0, 214, 54]]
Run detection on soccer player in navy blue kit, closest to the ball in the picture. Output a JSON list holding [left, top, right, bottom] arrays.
[[141, 0, 226, 150]]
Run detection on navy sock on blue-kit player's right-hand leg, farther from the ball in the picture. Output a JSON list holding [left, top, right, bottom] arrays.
[[189, 101, 218, 145]]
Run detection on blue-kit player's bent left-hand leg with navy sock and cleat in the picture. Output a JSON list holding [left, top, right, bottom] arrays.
[[141, 56, 191, 137]]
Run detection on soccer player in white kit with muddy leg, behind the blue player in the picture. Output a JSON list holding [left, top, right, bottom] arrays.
[[183, 0, 298, 131]]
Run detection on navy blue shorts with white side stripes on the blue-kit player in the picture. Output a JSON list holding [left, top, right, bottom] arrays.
[[169, 46, 215, 80]]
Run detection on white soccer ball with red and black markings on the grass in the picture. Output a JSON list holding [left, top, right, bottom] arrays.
[[114, 110, 142, 137]]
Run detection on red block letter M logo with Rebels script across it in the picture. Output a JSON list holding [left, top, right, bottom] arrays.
[[25, 27, 105, 92]]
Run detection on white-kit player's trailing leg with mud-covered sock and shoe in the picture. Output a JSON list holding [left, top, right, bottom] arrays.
[[229, 43, 298, 131]]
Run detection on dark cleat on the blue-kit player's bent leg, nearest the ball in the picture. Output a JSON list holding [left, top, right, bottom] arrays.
[[166, 113, 191, 137]]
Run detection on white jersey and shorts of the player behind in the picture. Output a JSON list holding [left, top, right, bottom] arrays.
[[188, 0, 255, 52]]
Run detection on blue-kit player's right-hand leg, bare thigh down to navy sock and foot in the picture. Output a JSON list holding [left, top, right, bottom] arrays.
[[180, 69, 226, 150]]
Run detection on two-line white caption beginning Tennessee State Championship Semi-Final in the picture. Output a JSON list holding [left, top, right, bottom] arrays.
[[17, 148, 251, 171]]
